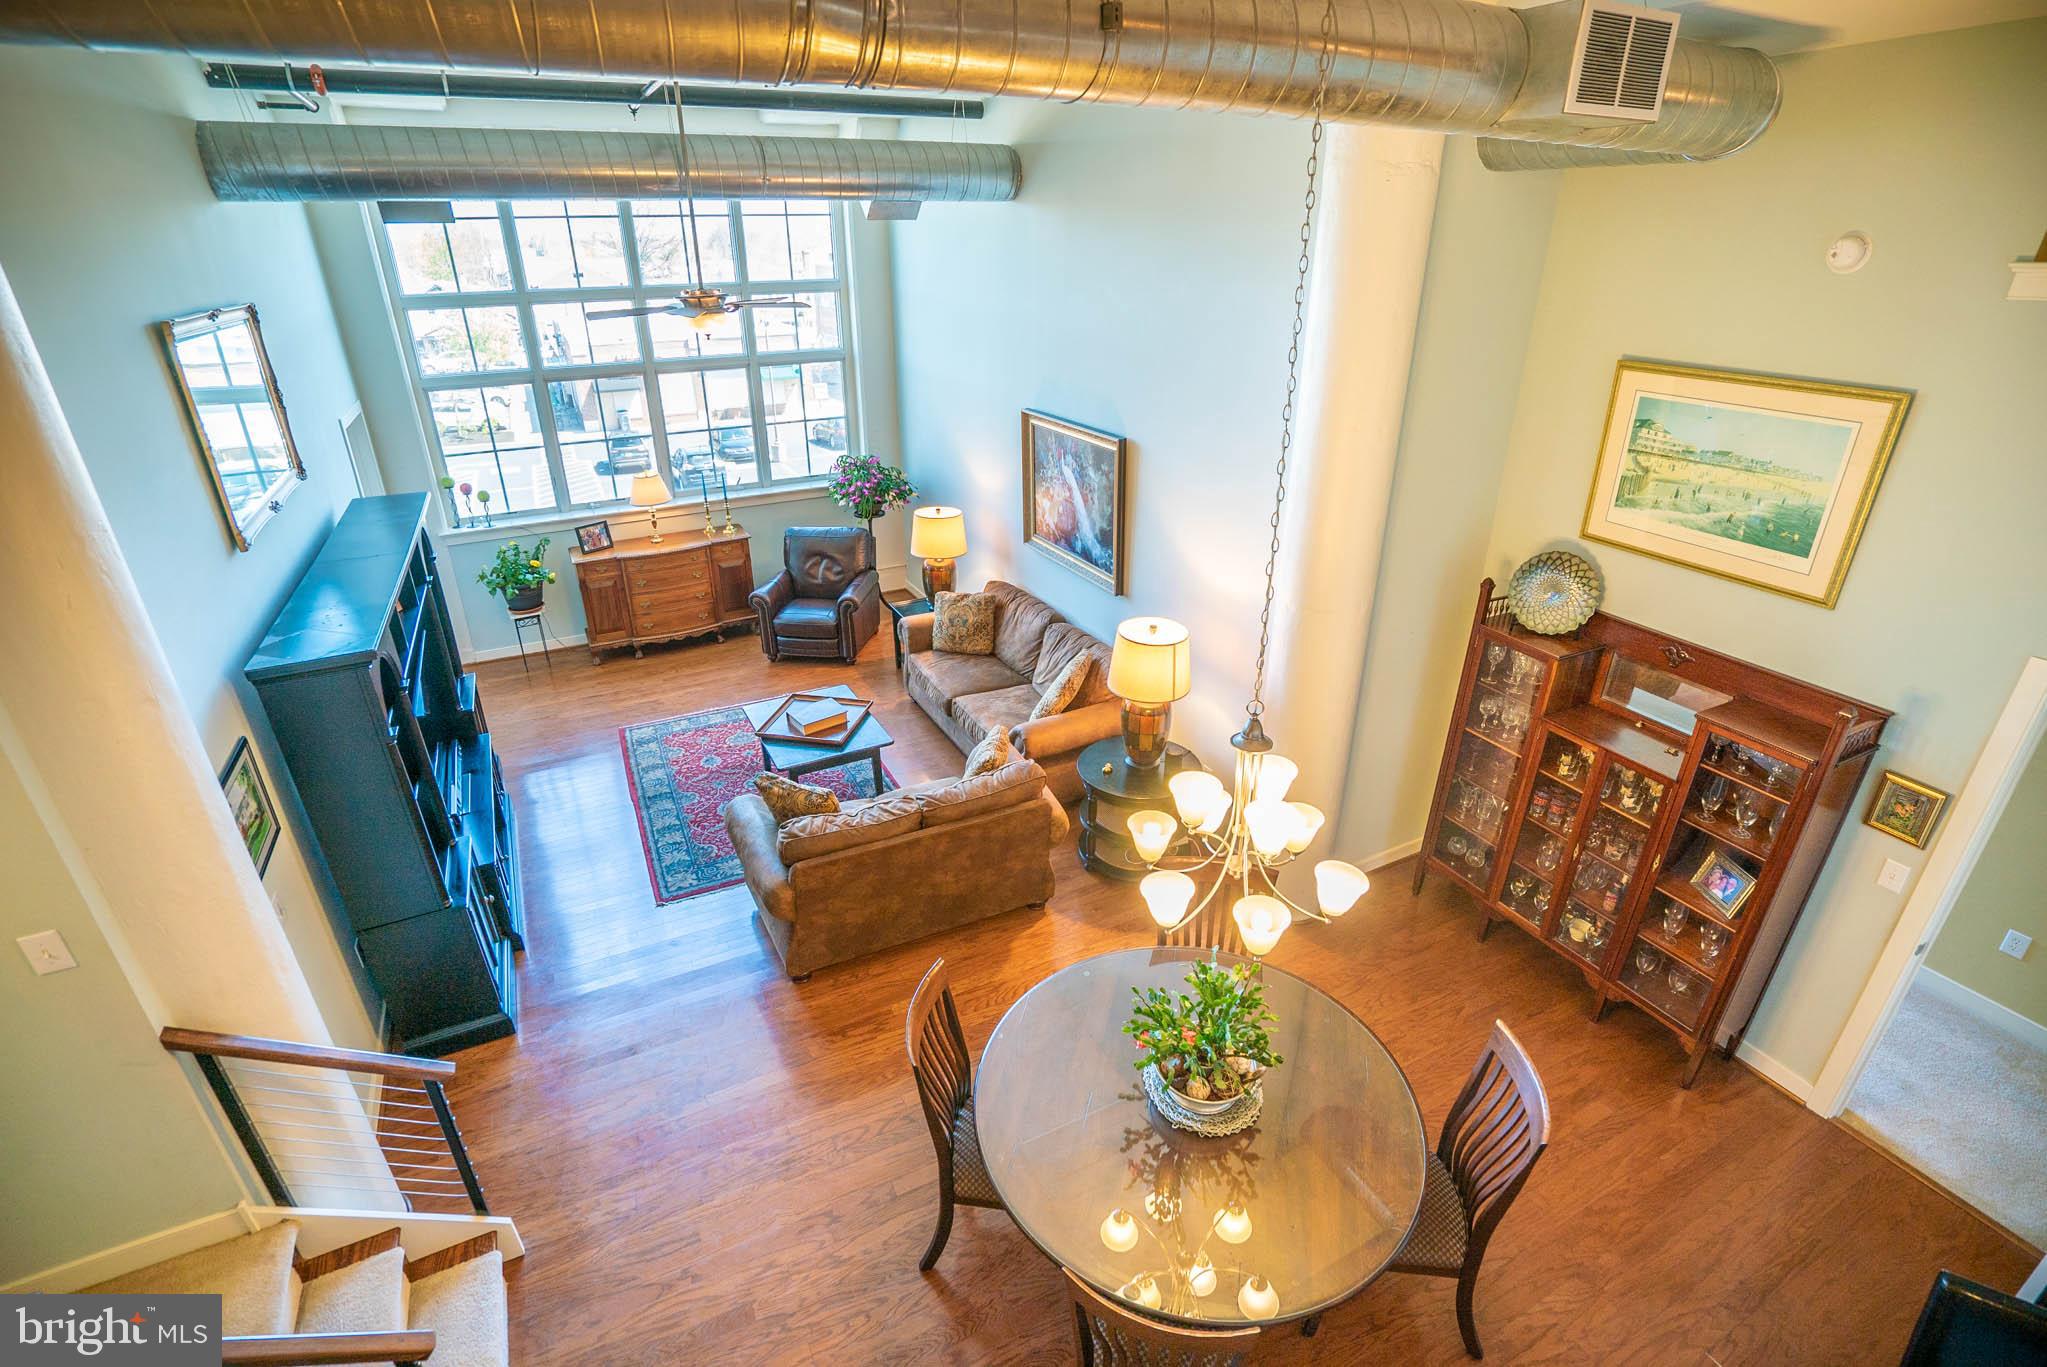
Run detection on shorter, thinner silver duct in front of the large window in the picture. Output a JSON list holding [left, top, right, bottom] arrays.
[[199, 123, 1021, 201]]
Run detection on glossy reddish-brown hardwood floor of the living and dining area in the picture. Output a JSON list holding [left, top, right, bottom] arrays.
[[450, 636, 2033, 1367]]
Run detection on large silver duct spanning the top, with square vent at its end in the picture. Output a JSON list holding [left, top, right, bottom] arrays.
[[0, 0, 1779, 160]]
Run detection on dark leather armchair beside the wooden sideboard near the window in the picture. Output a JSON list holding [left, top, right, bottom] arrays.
[[747, 526, 882, 665]]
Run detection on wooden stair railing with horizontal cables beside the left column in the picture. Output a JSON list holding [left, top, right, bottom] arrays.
[[158, 1027, 489, 1211]]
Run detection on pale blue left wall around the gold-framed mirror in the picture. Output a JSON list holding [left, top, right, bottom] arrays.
[[0, 47, 377, 1046]]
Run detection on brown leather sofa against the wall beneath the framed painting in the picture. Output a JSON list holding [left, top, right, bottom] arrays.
[[899, 579, 1122, 802]]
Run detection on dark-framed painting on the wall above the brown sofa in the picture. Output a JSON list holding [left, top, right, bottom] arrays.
[[1024, 409, 1128, 598]]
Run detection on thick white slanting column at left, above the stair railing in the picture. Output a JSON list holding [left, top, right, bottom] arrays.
[[0, 261, 330, 1044]]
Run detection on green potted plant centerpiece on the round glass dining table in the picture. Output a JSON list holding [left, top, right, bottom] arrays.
[[1124, 962, 1286, 1115]]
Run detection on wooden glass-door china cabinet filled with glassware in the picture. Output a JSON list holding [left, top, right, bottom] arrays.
[[1414, 579, 1889, 1087]]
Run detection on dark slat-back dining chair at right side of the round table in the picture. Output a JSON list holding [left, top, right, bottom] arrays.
[[1388, 1021, 1550, 1357]]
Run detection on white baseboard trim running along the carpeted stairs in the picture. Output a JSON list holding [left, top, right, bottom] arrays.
[[0, 1203, 526, 1295]]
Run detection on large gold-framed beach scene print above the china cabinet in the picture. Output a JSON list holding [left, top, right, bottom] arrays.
[[1584, 360, 1912, 608]]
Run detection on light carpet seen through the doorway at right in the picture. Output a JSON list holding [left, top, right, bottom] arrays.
[[1840, 984, 2047, 1246]]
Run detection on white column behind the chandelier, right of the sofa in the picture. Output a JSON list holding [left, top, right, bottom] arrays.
[[1265, 125, 1443, 857]]
